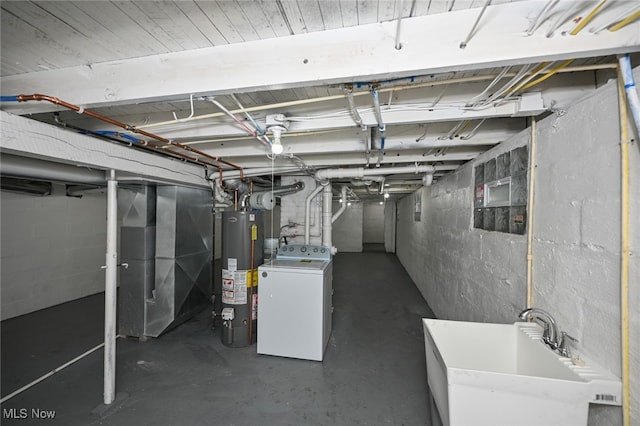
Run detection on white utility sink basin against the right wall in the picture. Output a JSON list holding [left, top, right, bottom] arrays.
[[422, 319, 622, 426]]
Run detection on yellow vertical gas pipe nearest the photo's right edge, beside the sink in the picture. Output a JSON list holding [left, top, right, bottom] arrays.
[[618, 68, 631, 426]]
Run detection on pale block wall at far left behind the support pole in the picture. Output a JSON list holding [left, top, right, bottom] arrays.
[[0, 185, 106, 320]]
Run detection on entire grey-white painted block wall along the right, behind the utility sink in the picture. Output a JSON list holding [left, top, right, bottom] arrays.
[[397, 70, 640, 426]]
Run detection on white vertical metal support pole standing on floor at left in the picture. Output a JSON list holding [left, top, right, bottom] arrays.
[[103, 170, 118, 405]]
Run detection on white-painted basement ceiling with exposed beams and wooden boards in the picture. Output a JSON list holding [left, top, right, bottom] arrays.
[[0, 0, 640, 200]]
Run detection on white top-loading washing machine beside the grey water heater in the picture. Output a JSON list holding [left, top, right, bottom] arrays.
[[257, 244, 333, 361]]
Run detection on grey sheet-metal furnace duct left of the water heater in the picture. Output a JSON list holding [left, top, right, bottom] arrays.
[[118, 185, 213, 337]]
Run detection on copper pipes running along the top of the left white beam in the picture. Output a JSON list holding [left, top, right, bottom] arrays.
[[17, 93, 245, 180]]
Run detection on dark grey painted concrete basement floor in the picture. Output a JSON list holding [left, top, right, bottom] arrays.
[[2, 251, 433, 425]]
